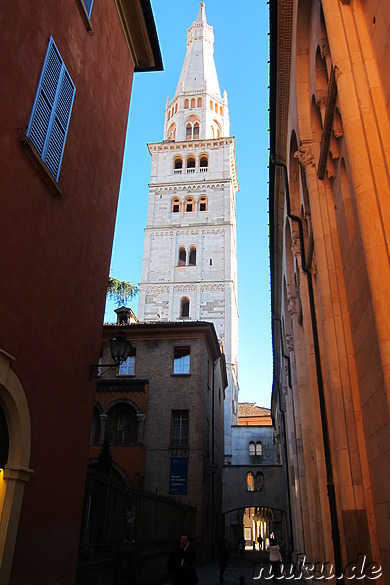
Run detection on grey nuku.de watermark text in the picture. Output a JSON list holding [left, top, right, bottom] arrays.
[[253, 554, 382, 582]]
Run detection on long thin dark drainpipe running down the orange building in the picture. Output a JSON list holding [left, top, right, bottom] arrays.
[[271, 154, 344, 583]]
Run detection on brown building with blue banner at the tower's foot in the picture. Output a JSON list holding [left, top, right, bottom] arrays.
[[86, 314, 227, 564]]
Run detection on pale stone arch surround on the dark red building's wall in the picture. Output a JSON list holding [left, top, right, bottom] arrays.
[[0, 350, 33, 583]]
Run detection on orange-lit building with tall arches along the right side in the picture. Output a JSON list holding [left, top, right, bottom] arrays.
[[270, 0, 390, 583]]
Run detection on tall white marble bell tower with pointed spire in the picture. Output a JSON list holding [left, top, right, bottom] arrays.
[[138, 3, 238, 458]]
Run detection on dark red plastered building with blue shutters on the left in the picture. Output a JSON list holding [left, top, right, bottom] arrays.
[[0, 0, 162, 585]]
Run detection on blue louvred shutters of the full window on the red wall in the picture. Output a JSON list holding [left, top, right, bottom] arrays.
[[27, 37, 76, 181]]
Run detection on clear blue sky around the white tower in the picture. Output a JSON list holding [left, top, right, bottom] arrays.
[[104, 0, 272, 407]]
